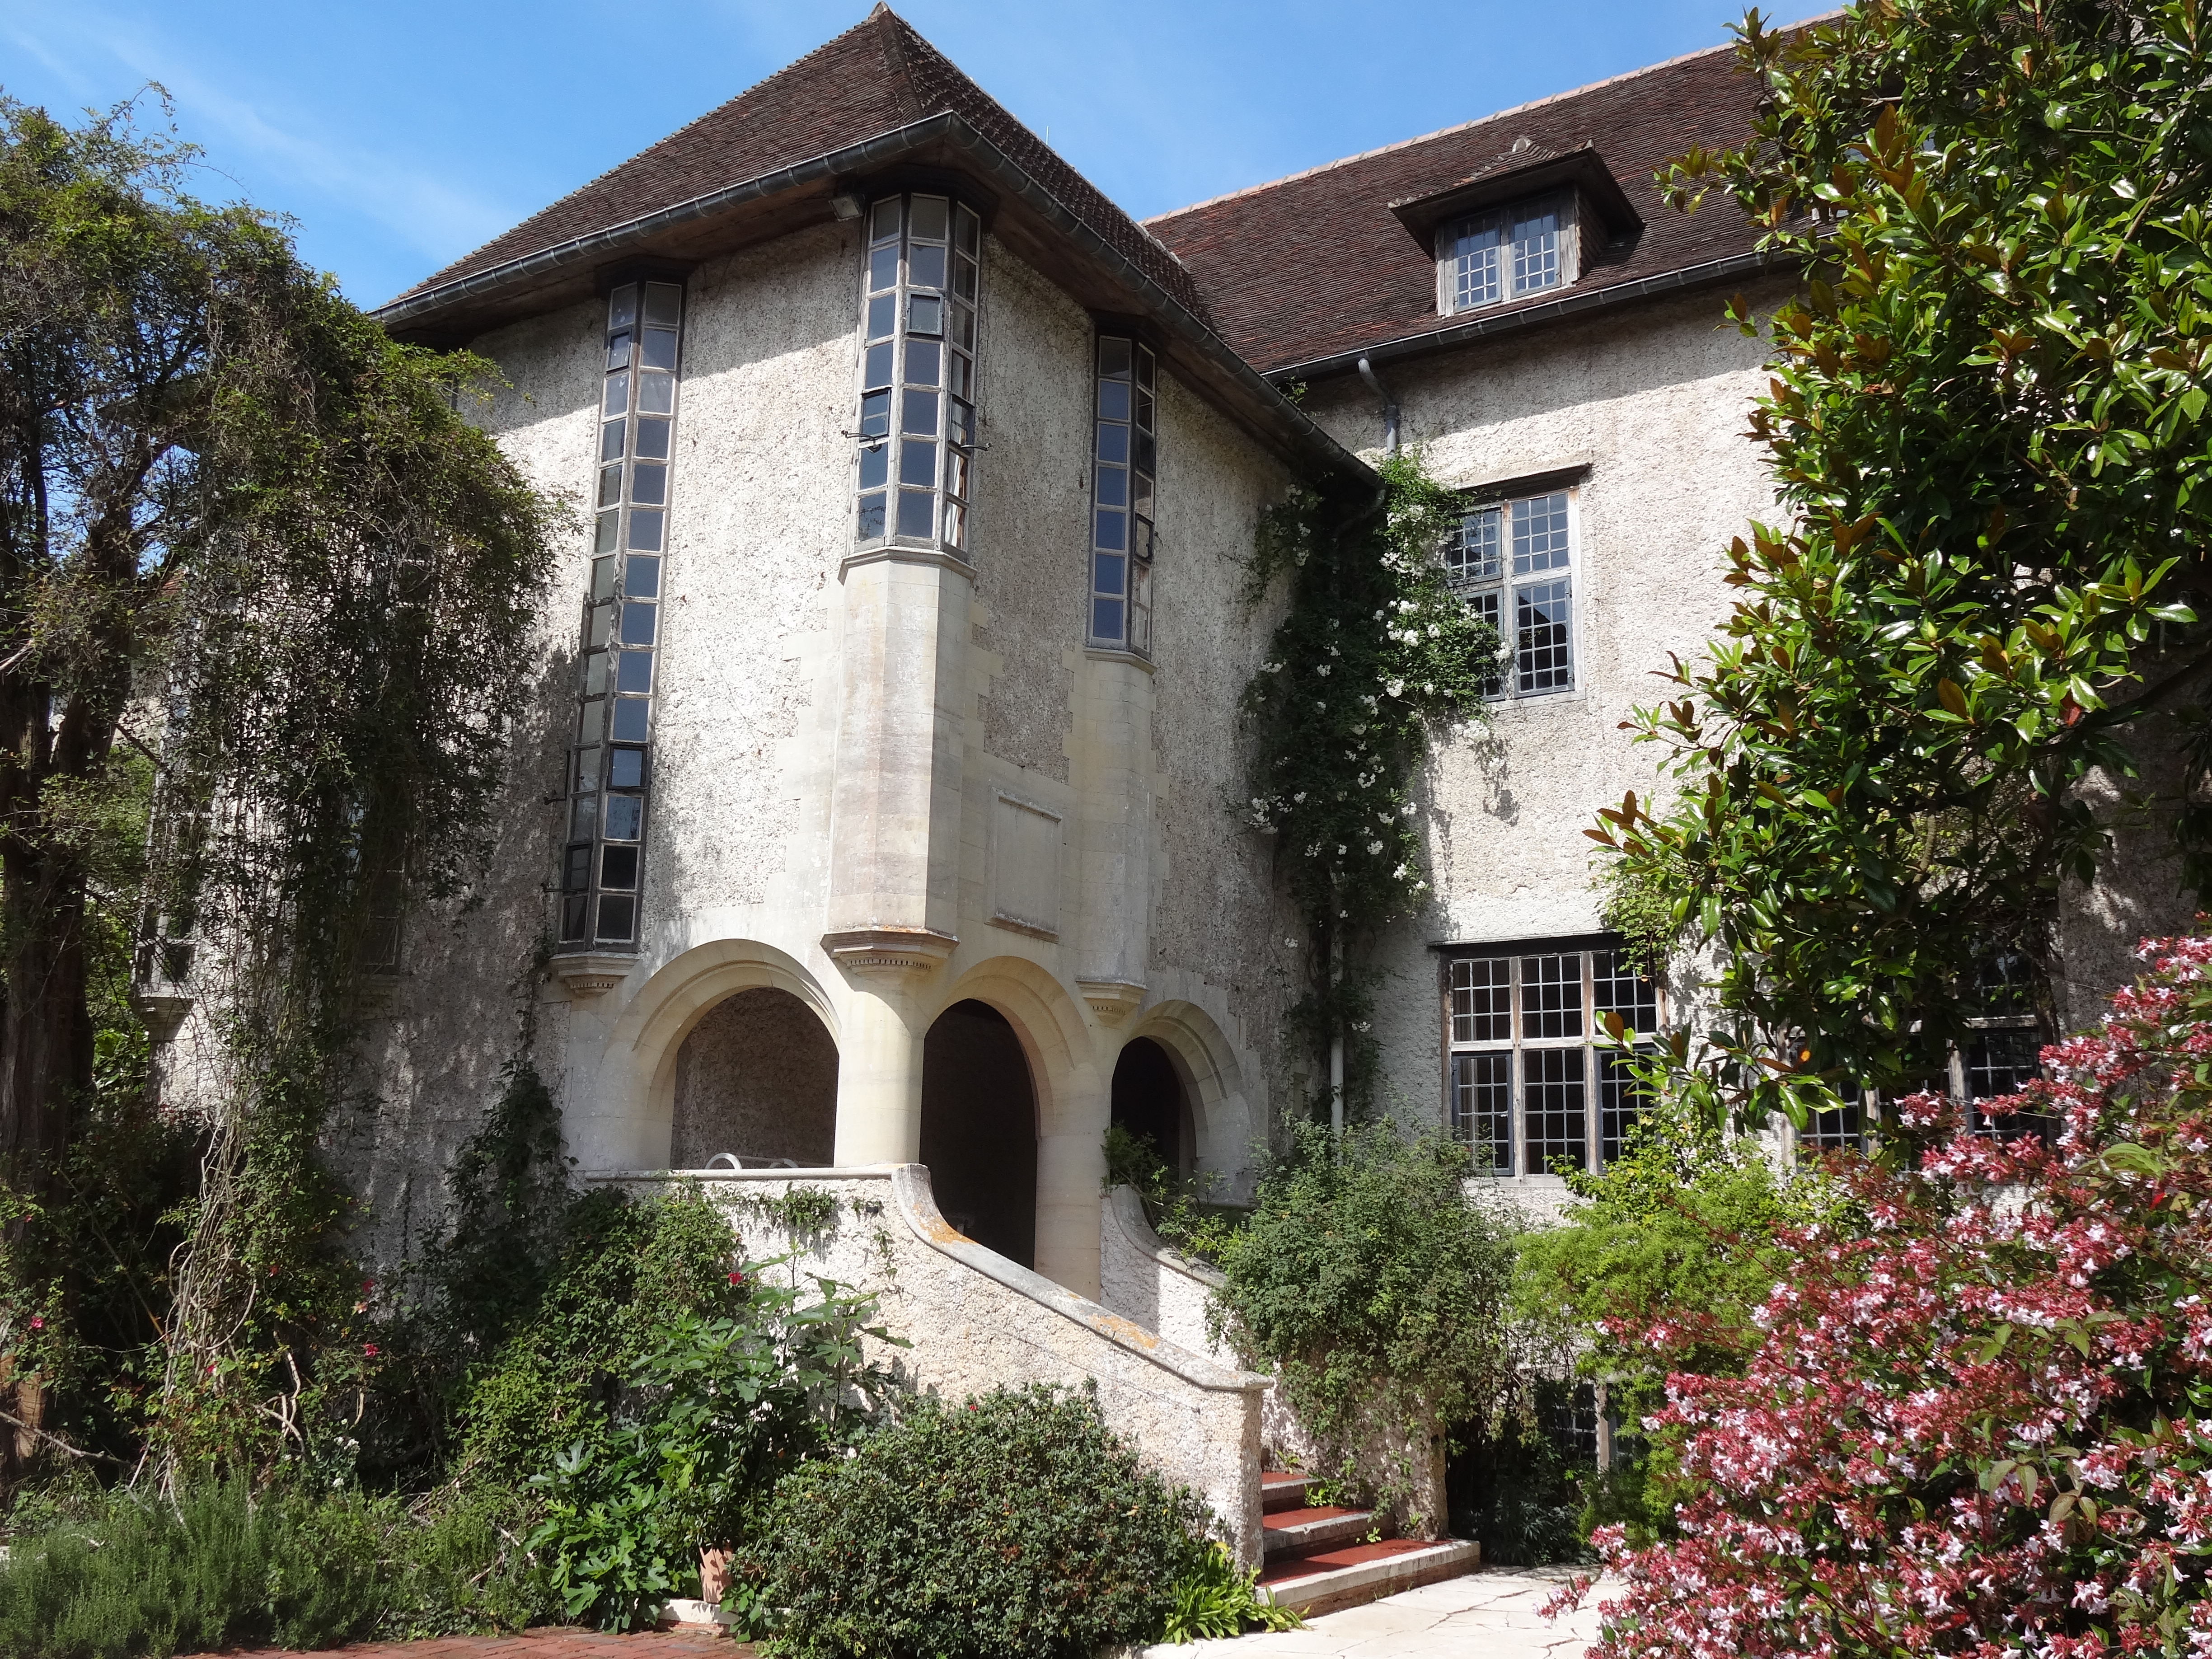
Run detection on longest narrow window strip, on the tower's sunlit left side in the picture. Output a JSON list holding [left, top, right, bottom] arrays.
[[560, 283, 684, 947]]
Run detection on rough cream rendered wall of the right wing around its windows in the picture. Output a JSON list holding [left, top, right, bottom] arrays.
[[1305, 290, 1781, 1186]]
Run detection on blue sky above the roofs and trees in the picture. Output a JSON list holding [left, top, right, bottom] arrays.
[[0, 0, 1761, 305]]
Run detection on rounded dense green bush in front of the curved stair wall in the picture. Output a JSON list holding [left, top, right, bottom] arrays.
[[739, 1387, 1210, 1659]]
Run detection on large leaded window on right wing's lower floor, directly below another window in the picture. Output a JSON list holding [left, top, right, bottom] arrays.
[[1444, 947, 1659, 1175]]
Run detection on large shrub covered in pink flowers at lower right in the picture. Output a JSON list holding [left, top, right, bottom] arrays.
[[1562, 938, 2212, 1659]]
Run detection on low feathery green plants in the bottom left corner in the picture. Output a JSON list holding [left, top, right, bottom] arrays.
[[0, 1482, 551, 1659]]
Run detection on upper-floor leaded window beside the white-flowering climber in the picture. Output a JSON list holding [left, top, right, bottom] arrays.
[[1444, 489, 1575, 697]]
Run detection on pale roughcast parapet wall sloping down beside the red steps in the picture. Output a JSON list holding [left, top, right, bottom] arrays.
[[606, 1166, 1265, 1566]]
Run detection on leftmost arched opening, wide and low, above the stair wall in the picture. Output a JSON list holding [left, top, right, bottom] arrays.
[[668, 987, 836, 1170]]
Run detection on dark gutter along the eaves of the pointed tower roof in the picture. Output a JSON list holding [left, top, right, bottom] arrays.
[[383, 111, 1380, 489]]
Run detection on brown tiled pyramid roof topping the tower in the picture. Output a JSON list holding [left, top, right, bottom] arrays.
[[384, 5, 1210, 321]]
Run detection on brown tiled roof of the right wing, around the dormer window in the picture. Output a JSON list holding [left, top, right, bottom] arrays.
[[1146, 47, 1758, 374]]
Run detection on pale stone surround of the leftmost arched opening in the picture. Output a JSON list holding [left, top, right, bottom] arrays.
[[564, 940, 843, 1170]]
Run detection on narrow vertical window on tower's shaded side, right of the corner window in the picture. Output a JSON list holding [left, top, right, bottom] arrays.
[[1091, 334, 1159, 655]]
